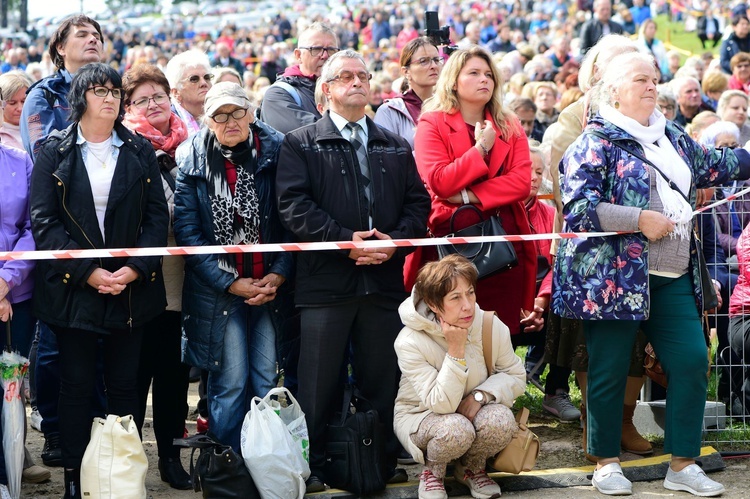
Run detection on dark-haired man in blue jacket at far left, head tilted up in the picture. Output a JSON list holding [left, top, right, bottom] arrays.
[[21, 15, 105, 472]]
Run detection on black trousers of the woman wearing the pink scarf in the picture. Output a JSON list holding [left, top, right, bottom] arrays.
[[136, 311, 190, 458]]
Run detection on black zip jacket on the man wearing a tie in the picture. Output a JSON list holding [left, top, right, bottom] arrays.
[[276, 112, 430, 306]]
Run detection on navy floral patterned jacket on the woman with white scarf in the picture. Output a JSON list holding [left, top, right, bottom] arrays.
[[552, 115, 750, 320]]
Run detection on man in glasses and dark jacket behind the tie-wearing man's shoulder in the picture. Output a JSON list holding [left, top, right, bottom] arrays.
[[260, 22, 339, 133]]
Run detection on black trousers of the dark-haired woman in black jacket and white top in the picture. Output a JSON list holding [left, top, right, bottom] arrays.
[[52, 326, 143, 468]]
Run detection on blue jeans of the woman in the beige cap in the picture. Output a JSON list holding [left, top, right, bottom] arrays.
[[207, 298, 276, 452]]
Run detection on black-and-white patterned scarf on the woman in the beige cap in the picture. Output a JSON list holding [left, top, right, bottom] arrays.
[[206, 132, 260, 277]]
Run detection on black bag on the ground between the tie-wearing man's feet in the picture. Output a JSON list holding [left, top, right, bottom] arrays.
[[323, 385, 386, 497]]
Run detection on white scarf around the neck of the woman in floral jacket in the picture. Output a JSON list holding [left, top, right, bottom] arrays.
[[599, 105, 693, 239]]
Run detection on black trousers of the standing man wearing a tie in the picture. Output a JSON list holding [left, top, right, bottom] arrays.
[[297, 296, 402, 480]]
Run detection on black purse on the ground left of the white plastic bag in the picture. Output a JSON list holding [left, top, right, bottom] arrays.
[[174, 435, 261, 499]]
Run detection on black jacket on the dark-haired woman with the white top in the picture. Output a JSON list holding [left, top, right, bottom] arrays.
[[30, 123, 169, 333]]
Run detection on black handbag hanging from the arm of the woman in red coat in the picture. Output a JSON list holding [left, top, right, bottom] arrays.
[[437, 204, 518, 279]]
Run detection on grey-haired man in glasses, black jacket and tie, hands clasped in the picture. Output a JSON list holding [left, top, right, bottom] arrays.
[[276, 50, 430, 492]]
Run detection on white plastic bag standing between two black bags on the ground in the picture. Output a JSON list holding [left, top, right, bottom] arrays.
[[240, 390, 310, 499]]
